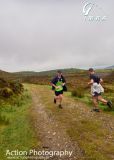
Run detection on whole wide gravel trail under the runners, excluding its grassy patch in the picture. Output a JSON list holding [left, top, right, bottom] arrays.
[[30, 85, 114, 160]]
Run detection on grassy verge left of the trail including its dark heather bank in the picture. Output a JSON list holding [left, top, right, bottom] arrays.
[[0, 78, 38, 160]]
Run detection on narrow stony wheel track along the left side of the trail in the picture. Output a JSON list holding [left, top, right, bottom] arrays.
[[31, 87, 82, 160]]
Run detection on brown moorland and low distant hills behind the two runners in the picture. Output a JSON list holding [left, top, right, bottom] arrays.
[[0, 66, 114, 86]]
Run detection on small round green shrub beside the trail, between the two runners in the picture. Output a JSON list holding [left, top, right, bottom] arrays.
[[71, 88, 84, 98]]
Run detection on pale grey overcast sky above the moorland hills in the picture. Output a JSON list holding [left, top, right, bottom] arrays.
[[0, 0, 114, 72]]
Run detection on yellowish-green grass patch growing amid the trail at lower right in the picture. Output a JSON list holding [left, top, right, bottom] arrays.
[[67, 120, 110, 160]]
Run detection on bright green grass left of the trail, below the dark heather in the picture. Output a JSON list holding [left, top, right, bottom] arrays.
[[0, 88, 38, 160]]
